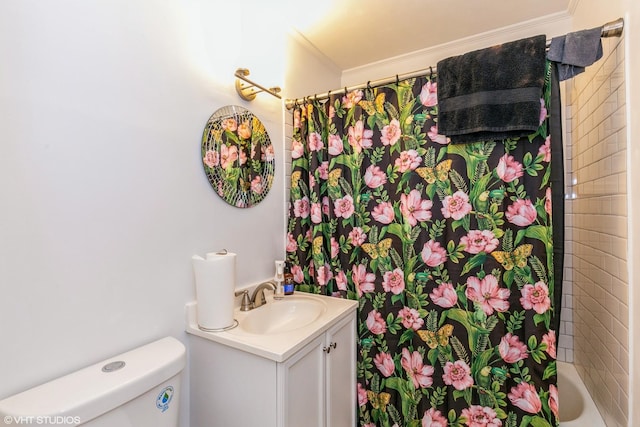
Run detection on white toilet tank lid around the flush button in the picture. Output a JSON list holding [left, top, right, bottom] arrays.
[[0, 337, 186, 423]]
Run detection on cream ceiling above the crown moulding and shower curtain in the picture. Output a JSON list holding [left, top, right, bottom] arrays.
[[291, 0, 570, 71]]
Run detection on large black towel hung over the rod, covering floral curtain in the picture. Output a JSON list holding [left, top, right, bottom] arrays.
[[438, 35, 546, 143]]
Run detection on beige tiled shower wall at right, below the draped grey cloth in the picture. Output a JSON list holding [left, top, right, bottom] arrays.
[[558, 34, 629, 427]]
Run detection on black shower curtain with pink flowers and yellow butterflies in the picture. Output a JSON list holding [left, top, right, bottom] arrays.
[[287, 64, 558, 427]]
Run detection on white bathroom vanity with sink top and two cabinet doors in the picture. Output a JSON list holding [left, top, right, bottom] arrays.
[[187, 292, 358, 427]]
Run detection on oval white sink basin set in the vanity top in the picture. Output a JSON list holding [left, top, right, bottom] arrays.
[[237, 295, 327, 334]]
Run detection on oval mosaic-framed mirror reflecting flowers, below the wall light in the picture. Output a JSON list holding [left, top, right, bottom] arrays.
[[202, 105, 275, 208]]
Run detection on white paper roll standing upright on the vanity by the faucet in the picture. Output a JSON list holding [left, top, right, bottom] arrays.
[[192, 251, 236, 330]]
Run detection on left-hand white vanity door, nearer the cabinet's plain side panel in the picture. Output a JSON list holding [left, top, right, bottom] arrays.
[[278, 335, 324, 427]]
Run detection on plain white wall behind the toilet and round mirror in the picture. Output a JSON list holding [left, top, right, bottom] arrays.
[[0, 0, 285, 426]]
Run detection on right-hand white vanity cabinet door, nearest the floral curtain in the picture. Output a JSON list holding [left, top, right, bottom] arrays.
[[325, 314, 357, 427]]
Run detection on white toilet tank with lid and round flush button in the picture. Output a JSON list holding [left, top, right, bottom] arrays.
[[0, 337, 186, 427]]
